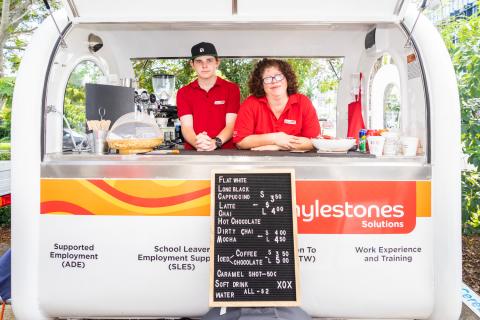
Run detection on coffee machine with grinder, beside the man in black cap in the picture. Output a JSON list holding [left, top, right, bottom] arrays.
[[150, 74, 183, 148]]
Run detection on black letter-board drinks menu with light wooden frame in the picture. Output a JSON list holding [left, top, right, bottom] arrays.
[[210, 170, 299, 307]]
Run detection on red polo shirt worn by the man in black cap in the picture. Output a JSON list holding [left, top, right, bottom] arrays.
[[177, 77, 240, 150]]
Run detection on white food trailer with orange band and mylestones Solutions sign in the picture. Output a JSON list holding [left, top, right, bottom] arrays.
[[11, 0, 461, 320]]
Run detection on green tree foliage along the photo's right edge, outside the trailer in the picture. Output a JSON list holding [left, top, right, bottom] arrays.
[[440, 8, 480, 233]]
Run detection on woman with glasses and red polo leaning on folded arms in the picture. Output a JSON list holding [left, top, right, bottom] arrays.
[[233, 59, 320, 150]]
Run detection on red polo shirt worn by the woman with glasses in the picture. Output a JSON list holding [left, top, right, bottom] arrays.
[[233, 93, 320, 143]]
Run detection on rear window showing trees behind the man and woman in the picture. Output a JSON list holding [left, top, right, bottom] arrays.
[[132, 57, 344, 136]]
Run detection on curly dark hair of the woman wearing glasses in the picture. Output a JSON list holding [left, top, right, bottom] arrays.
[[248, 58, 298, 98]]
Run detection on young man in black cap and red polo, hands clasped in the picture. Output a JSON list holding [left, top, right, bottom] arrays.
[[177, 42, 240, 151]]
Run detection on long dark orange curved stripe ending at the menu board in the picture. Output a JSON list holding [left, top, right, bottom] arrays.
[[87, 180, 210, 208]]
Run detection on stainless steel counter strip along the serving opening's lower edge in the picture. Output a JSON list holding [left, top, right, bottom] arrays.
[[41, 150, 431, 180]]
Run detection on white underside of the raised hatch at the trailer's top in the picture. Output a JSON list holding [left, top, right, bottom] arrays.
[[63, 0, 408, 22]]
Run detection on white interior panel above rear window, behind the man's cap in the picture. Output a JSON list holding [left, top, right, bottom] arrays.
[[73, 23, 376, 58]]
